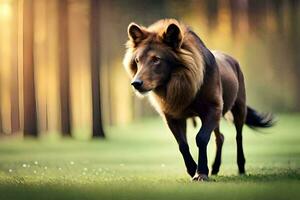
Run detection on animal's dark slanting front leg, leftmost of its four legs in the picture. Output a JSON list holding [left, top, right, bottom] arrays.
[[166, 116, 197, 177]]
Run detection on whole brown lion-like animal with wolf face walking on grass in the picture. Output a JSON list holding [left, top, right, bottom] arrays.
[[123, 19, 272, 180]]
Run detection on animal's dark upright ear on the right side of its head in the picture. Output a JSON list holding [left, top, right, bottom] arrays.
[[163, 24, 182, 49]]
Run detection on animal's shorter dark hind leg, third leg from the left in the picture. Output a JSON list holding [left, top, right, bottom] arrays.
[[211, 127, 224, 175]]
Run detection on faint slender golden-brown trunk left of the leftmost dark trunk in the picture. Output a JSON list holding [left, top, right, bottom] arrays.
[[10, 1, 20, 133]]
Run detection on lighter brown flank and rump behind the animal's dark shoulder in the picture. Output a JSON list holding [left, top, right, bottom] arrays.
[[212, 51, 244, 114]]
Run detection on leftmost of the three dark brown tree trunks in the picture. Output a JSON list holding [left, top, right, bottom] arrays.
[[23, 0, 38, 137]]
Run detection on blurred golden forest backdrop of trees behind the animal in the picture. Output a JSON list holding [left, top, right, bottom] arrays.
[[0, 0, 300, 137]]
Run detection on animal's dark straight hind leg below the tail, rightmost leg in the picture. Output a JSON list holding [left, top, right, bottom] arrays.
[[231, 102, 246, 174]]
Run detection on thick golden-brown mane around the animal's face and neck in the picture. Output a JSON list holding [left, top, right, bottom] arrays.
[[123, 19, 204, 117]]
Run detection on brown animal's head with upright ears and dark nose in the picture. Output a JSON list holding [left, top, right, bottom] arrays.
[[123, 20, 183, 94]]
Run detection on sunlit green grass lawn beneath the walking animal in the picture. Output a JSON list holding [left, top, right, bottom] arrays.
[[0, 114, 300, 200]]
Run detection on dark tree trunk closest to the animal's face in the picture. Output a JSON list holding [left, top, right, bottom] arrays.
[[90, 0, 105, 138]]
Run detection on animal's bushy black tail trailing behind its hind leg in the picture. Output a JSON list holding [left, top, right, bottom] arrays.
[[245, 106, 276, 129]]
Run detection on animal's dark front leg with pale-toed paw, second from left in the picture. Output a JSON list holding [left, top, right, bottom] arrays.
[[193, 110, 220, 181]]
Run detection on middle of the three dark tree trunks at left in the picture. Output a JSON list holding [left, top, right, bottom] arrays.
[[58, 0, 71, 136]]
